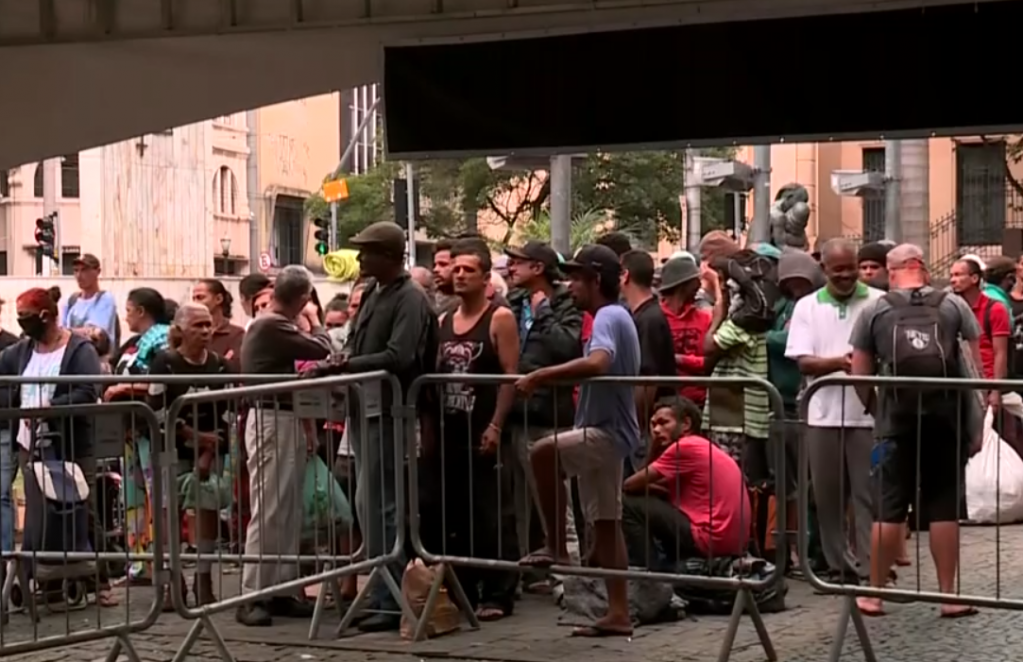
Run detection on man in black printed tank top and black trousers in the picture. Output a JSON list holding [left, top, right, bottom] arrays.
[[422, 239, 519, 620]]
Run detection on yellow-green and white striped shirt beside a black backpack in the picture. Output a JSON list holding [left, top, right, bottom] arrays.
[[704, 319, 770, 439]]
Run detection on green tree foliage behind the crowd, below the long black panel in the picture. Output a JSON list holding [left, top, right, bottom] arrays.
[[305, 149, 733, 248]]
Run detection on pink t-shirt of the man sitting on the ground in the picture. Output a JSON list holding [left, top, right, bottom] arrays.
[[651, 435, 752, 557]]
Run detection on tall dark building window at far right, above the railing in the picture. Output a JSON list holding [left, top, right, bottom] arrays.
[[955, 140, 1009, 246]]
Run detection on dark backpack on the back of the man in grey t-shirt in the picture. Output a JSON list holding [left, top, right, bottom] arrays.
[[879, 290, 960, 410]]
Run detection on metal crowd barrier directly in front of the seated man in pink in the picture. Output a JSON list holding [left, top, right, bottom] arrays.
[[406, 374, 788, 662]]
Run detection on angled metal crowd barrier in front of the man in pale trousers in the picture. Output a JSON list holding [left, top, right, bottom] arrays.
[[161, 371, 407, 662]]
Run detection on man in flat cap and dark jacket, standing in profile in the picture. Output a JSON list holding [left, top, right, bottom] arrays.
[[338, 221, 437, 631]]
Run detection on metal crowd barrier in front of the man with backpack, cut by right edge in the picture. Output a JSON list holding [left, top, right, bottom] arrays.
[[798, 376, 1023, 662]]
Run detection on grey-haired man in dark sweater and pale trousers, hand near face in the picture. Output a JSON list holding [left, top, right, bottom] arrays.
[[236, 265, 330, 626]]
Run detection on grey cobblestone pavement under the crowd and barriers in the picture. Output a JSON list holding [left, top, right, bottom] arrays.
[[6, 527, 1023, 662]]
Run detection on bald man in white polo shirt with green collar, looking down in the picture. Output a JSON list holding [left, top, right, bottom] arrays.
[[785, 239, 884, 582]]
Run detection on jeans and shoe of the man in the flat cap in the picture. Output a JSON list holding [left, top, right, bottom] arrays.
[[348, 416, 405, 611]]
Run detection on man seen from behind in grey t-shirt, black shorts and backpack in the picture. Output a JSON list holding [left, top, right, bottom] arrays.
[[850, 244, 982, 618]]
